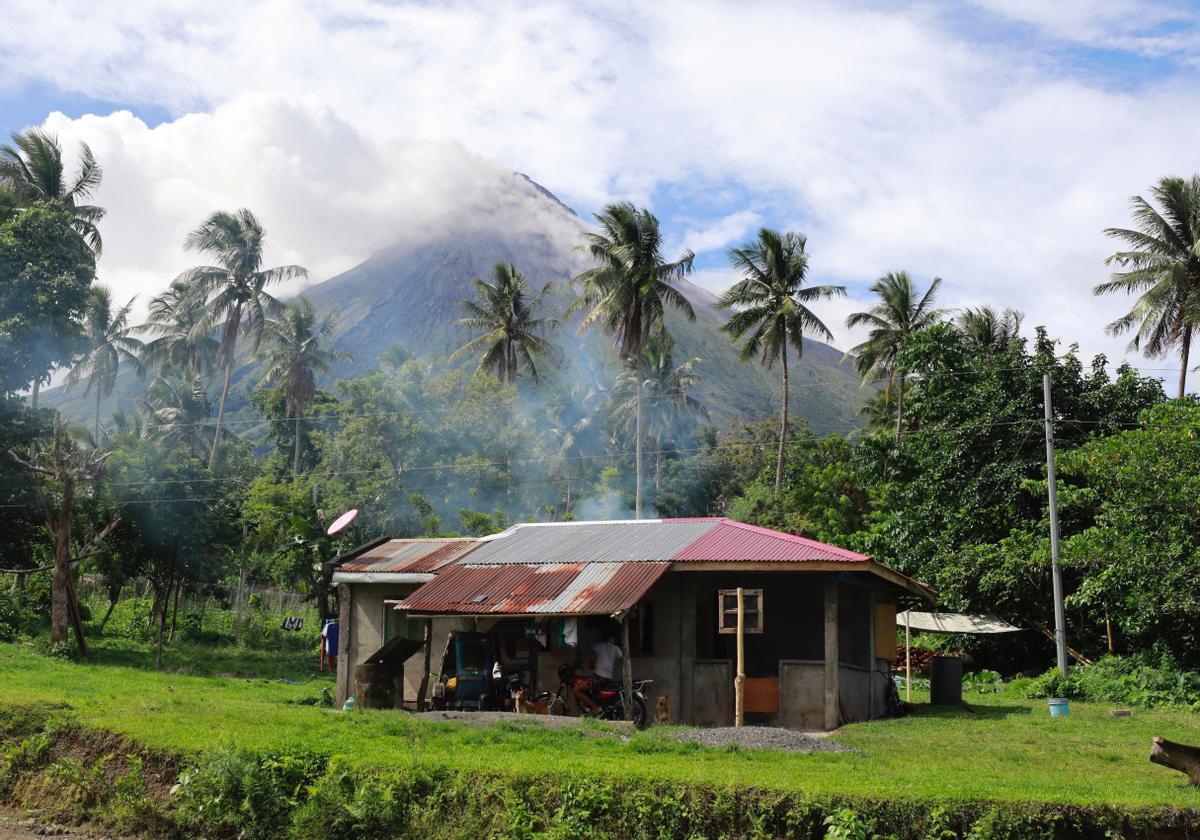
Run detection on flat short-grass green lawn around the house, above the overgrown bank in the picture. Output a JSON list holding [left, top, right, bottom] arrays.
[[0, 641, 1200, 808]]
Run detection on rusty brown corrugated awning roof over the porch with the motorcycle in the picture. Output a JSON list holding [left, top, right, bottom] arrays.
[[397, 562, 671, 616]]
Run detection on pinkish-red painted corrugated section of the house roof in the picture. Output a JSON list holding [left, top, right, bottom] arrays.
[[666, 520, 870, 563]]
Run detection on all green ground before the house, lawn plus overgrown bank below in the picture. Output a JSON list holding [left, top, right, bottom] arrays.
[[0, 641, 1200, 836]]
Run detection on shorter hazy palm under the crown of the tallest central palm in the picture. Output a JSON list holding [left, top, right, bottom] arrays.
[[613, 332, 708, 492]]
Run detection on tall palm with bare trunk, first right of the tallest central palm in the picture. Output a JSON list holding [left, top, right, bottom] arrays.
[[718, 228, 846, 497]]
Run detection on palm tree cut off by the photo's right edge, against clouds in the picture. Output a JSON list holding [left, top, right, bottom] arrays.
[[1093, 175, 1200, 397]]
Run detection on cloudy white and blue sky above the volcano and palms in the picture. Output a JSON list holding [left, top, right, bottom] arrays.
[[0, 0, 1200, 367]]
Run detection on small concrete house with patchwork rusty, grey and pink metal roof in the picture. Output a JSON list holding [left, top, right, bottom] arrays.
[[334, 517, 932, 730]]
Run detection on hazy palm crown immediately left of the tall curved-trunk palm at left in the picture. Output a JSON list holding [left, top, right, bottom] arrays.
[[138, 280, 221, 378]]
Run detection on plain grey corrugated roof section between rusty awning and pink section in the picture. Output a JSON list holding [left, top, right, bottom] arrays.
[[463, 520, 719, 565]]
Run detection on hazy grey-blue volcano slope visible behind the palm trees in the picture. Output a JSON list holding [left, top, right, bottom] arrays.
[[44, 174, 870, 436]]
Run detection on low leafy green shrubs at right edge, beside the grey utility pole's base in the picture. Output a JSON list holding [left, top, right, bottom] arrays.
[[1014, 655, 1200, 710]]
